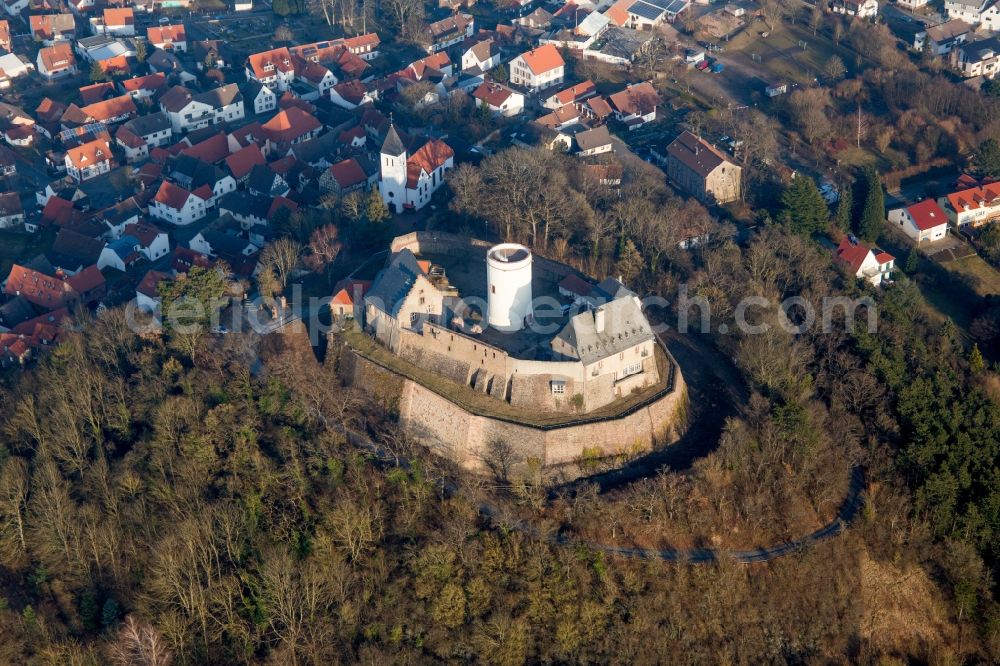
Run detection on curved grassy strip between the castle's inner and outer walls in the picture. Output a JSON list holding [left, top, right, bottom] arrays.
[[343, 327, 670, 425]]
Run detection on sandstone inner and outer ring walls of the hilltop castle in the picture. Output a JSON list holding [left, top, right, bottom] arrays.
[[346, 232, 687, 473]]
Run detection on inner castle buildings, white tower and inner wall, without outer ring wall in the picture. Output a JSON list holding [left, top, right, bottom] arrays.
[[363, 235, 660, 413]]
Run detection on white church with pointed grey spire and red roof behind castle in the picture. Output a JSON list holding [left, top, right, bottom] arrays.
[[379, 125, 455, 213]]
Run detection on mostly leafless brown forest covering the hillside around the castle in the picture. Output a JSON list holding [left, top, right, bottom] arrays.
[[0, 189, 1000, 664]]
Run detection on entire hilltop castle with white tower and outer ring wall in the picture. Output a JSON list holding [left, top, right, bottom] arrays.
[[344, 232, 687, 477]]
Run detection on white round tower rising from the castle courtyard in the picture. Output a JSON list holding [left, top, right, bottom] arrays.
[[486, 243, 531, 331]]
